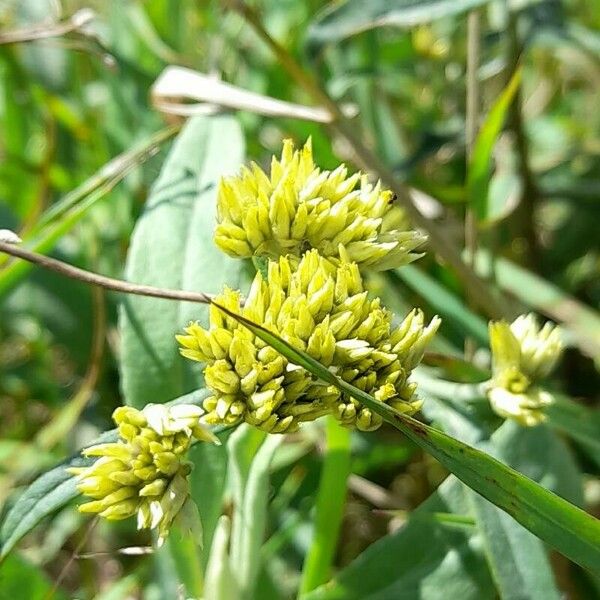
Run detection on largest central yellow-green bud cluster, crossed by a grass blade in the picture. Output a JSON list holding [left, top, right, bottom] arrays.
[[178, 250, 439, 433]]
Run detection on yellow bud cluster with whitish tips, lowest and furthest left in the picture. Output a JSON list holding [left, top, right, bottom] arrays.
[[69, 404, 218, 545]]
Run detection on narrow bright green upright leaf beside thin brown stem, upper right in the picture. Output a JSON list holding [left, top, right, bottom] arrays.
[[467, 69, 522, 222]]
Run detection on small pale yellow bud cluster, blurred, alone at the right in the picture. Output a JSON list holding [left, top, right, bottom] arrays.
[[488, 314, 562, 427]]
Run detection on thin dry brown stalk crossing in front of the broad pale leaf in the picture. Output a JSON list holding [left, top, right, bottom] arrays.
[[0, 241, 214, 304]]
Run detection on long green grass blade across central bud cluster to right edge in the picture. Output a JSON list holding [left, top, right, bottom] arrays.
[[215, 303, 600, 571]]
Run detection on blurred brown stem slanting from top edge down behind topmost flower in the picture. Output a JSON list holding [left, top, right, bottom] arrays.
[[224, 0, 505, 318]]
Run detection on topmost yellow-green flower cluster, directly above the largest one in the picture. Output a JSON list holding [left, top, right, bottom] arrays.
[[215, 140, 426, 270]]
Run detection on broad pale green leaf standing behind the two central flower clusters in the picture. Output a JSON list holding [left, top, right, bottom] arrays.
[[119, 115, 250, 408]]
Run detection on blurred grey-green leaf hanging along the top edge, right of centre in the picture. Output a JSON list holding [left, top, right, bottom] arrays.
[[307, 0, 488, 49]]
